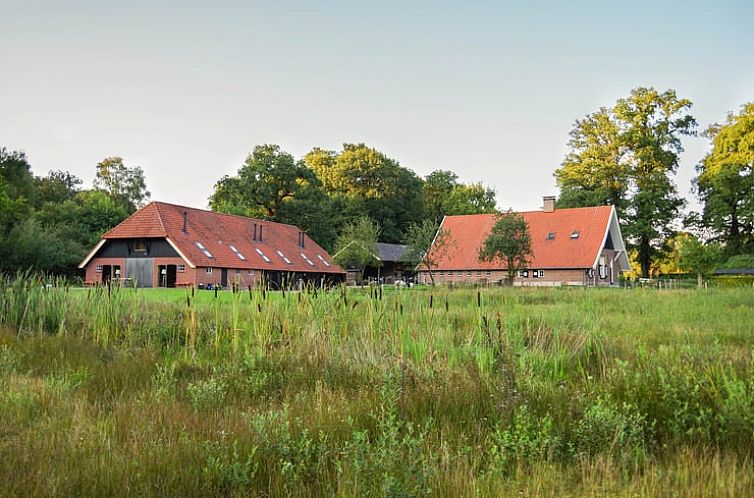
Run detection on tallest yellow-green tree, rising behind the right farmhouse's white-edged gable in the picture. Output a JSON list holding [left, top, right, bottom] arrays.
[[555, 88, 696, 277]]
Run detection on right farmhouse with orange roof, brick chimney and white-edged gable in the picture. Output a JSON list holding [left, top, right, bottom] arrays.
[[419, 197, 630, 285]]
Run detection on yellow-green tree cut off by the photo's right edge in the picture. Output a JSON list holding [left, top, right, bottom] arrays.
[[694, 103, 754, 255]]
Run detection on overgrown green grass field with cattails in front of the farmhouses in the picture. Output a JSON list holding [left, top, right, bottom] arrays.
[[0, 279, 754, 497]]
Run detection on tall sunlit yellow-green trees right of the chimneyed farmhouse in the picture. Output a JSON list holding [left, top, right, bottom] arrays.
[[555, 87, 754, 277]]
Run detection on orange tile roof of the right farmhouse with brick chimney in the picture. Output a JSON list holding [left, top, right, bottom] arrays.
[[437, 206, 623, 270]]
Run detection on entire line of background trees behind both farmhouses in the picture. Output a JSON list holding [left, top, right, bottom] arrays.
[[0, 87, 754, 277]]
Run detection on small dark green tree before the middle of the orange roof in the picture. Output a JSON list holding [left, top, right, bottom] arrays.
[[479, 211, 532, 285]]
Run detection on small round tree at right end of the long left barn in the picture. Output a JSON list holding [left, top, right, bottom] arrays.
[[333, 216, 382, 279]]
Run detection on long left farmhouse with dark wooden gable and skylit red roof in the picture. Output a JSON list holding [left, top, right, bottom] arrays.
[[79, 202, 345, 288]]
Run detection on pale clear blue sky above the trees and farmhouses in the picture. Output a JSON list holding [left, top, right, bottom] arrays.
[[0, 0, 754, 210]]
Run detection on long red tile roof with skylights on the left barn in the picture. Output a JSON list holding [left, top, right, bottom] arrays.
[[102, 202, 344, 273]]
